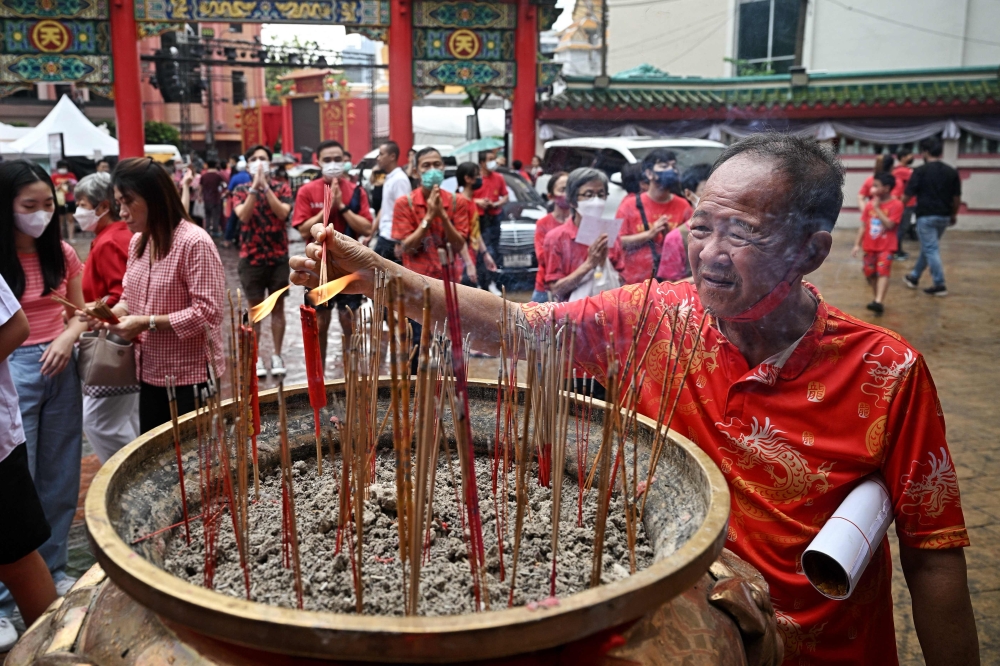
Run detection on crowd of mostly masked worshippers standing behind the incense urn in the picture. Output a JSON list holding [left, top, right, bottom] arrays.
[[0, 131, 961, 652]]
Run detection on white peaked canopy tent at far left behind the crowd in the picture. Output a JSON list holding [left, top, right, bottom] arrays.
[[0, 95, 118, 159]]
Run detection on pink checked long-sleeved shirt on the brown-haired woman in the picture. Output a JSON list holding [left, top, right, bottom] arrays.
[[122, 220, 226, 386]]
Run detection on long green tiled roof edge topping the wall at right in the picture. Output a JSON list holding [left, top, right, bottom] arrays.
[[542, 65, 1000, 110]]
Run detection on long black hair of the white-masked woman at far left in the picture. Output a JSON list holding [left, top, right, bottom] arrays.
[[0, 160, 66, 300]]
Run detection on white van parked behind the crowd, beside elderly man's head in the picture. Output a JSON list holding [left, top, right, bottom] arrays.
[[535, 136, 726, 217]]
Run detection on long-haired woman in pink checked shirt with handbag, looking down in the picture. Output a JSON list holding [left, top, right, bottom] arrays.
[[78, 157, 226, 432]]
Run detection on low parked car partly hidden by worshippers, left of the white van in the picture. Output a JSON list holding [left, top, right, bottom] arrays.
[[441, 168, 548, 289]]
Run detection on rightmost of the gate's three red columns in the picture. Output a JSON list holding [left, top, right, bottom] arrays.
[[511, 0, 538, 167]]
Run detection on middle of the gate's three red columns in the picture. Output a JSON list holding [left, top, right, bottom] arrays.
[[389, 0, 413, 160]]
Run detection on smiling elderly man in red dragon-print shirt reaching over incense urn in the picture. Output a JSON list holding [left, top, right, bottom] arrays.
[[292, 134, 979, 664]]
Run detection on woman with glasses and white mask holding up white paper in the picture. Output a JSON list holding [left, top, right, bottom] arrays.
[[542, 167, 624, 301]]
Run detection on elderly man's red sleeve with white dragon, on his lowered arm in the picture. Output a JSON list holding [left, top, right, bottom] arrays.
[[884, 345, 969, 549]]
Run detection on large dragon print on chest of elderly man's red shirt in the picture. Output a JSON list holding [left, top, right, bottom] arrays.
[[715, 417, 834, 504]]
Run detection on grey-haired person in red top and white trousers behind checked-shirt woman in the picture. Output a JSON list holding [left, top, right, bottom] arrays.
[[73, 173, 139, 463]]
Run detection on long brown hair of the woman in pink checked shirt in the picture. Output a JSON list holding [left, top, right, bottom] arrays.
[[111, 157, 191, 259]]
